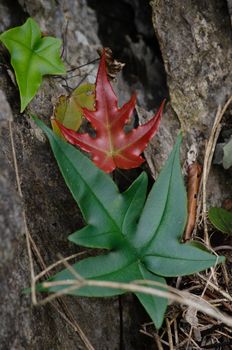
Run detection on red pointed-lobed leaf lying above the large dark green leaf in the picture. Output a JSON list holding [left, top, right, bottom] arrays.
[[56, 51, 164, 173]]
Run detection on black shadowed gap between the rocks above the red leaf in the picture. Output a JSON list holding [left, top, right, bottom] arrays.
[[87, 0, 168, 109]]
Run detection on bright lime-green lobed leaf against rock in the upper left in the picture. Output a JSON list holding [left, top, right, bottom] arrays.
[[0, 18, 65, 112]]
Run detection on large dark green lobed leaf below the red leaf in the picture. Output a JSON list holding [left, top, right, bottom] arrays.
[[33, 120, 224, 328]]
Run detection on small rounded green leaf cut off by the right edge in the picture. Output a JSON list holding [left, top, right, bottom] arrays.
[[208, 208, 232, 234]]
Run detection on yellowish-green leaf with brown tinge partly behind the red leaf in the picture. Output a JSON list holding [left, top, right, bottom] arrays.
[[51, 84, 95, 139]]
